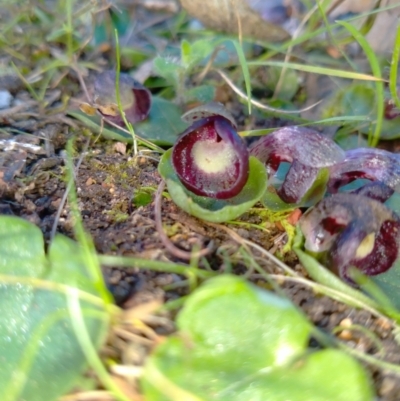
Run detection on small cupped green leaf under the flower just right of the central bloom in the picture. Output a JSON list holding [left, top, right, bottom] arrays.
[[261, 168, 329, 212]]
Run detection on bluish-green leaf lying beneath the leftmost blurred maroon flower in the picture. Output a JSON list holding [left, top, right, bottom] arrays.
[[68, 96, 187, 146]]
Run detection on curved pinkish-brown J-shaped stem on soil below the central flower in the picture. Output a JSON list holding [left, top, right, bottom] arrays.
[[154, 180, 213, 260]]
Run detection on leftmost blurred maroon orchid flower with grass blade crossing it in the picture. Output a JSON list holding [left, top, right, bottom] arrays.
[[94, 71, 151, 126]]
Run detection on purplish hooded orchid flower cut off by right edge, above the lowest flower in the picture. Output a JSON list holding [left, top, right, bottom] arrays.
[[328, 148, 400, 193]]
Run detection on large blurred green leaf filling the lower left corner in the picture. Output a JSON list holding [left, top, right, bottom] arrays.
[[0, 216, 108, 401]]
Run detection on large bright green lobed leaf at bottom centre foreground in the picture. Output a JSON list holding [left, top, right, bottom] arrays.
[[142, 275, 373, 401]]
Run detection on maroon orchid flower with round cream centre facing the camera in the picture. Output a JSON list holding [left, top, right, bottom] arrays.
[[172, 104, 249, 199]]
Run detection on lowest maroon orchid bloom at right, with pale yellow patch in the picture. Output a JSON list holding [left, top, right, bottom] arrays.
[[300, 193, 400, 283]]
